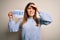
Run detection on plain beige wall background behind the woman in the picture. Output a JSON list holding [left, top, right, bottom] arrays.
[[0, 0, 60, 40]]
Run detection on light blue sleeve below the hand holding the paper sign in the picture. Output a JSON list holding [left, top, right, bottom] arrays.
[[8, 20, 20, 32]]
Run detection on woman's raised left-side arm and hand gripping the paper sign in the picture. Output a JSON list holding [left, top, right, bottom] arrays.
[[8, 11, 21, 32]]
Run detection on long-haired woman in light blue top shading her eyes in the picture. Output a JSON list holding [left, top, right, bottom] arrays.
[[8, 2, 52, 40]]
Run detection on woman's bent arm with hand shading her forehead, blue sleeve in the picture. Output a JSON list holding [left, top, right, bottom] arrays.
[[29, 5, 52, 25]]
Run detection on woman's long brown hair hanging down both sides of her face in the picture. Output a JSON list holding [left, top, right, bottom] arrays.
[[20, 2, 39, 26]]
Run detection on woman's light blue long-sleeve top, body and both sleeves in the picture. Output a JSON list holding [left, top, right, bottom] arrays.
[[8, 12, 52, 40]]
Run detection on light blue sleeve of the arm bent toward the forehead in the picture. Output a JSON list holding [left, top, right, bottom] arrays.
[[40, 12, 52, 25]]
